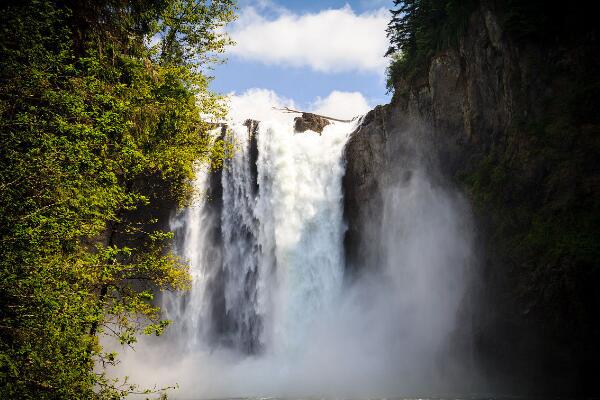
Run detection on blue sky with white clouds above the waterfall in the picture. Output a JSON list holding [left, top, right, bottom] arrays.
[[211, 0, 392, 118]]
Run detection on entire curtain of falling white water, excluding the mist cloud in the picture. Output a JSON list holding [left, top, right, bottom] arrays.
[[163, 115, 353, 354]]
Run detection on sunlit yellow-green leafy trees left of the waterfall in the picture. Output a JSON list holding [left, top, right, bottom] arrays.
[[0, 0, 234, 399]]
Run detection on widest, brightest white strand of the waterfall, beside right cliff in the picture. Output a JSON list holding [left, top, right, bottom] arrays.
[[256, 119, 352, 351]]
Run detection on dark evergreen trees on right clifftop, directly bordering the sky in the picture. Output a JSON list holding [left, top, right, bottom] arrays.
[[386, 0, 478, 91]]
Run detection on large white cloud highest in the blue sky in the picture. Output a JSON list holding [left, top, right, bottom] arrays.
[[230, 2, 389, 74]]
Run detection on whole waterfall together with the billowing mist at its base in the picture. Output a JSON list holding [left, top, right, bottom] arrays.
[[116, 111, 471, 399]]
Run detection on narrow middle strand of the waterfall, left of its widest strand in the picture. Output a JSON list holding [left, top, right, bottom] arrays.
[[218, 121, 262, 353]]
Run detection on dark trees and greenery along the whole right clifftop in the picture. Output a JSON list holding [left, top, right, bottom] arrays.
[[386, 0, 596, 91]]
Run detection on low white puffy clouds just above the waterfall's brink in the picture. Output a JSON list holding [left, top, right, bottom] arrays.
[[229, 88, 372, 121]]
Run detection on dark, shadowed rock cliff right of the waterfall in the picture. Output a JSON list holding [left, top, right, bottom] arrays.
[[343, 1, 600, 395]]
